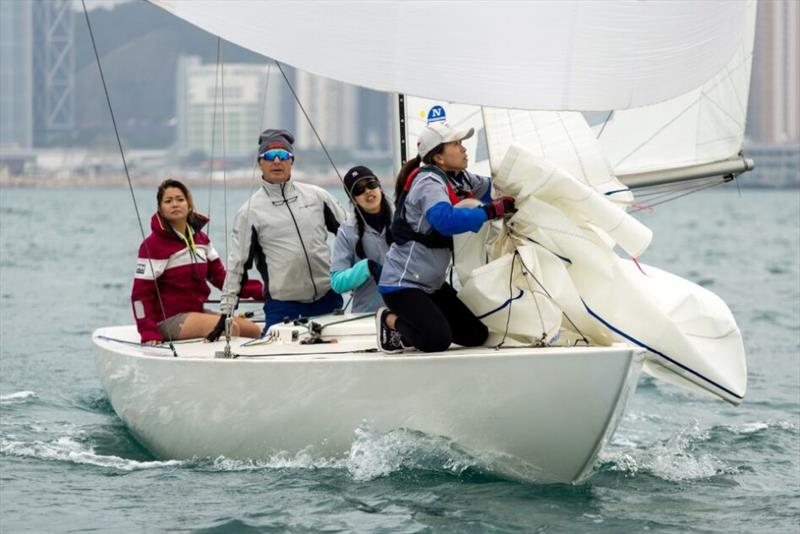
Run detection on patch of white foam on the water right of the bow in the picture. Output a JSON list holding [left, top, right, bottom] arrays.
[[600, 421, 725, 482]]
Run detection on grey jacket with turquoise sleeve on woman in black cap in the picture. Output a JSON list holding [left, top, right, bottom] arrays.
[[331, 209, 389, 313]]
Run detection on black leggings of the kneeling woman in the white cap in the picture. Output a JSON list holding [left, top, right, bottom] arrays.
[[382, 283, 489, 352]]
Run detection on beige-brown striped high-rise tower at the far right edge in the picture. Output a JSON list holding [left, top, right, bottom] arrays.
[[747, 0, 800, 144]]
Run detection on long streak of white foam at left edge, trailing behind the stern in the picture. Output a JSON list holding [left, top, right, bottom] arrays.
[[0, 436, 184, 471]]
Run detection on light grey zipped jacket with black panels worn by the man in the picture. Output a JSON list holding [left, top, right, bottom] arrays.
[[220, 180, 347, 314]]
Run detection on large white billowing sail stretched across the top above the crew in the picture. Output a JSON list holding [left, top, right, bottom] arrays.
[[145, 0, 747, 110]]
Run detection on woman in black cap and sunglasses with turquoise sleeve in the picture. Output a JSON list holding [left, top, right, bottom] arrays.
[[331, 165, 394, 313]]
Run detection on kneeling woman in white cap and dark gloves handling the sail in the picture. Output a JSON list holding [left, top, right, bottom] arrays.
[[376, 122, 514, 352]]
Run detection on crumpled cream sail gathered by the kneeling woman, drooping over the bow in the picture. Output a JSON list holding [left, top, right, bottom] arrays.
[[468, 145, 747, 404]]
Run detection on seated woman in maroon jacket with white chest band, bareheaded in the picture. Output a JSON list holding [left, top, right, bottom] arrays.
[[131, 180, 263, 344]]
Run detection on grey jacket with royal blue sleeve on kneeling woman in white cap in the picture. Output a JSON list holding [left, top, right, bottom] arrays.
[[378, 167, 491, 293]]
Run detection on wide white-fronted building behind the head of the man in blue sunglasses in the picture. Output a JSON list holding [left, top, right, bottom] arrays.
[[176, 56, 291, 158]]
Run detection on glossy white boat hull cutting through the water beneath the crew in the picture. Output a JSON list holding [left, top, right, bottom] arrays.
[[93, 325, 642, 482]]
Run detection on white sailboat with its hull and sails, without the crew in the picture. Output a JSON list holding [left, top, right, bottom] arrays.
[[92, 0, 755, 483]]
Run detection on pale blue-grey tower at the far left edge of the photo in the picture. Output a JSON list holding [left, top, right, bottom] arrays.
[[0, 1, 33, 151]]
